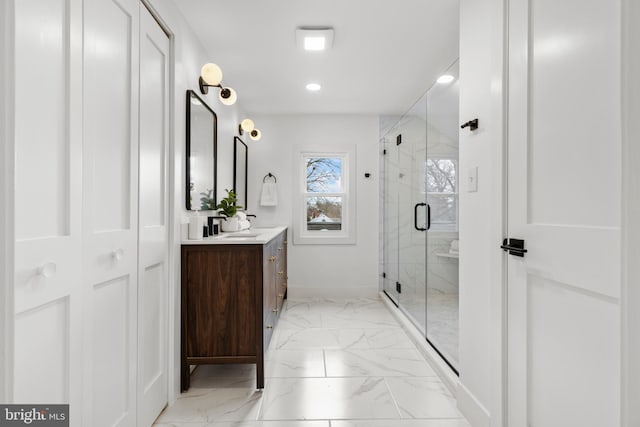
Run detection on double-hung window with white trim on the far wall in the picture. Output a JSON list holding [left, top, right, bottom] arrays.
[[294, 149, 355, 244]]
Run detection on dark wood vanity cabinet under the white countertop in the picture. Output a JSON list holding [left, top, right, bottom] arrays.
[[181, 229, 287, 391]]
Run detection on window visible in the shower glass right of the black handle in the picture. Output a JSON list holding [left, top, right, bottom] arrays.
[[425, 158, 458, 231]]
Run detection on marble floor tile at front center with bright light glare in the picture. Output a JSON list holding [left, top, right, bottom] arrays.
[[260, 377, 399, 420]]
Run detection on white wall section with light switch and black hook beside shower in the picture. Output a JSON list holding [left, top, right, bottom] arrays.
[[458, 0, 505, 427]]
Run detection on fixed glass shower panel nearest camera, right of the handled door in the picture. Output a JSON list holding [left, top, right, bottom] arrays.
[[425, 62, 460, 369]]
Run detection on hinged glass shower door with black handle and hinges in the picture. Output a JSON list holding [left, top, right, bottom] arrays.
[[382, 96, 427, 334]]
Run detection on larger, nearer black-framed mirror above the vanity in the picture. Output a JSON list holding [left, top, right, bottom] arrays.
[[185, 90, 218, 211]]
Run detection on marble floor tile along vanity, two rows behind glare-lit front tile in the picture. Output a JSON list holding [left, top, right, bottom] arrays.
[[272, 328, 369, 350]]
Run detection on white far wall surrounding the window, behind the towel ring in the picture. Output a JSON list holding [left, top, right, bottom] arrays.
[[243, 115, 380, 297]]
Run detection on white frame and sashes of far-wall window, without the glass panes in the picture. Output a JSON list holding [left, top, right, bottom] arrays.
[[293, 144, 356, 245]]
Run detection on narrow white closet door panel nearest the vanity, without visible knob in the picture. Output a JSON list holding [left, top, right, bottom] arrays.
[[138, 7, 169, 427]]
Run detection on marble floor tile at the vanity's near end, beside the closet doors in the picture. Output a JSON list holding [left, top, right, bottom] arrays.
[[158, 387, 262, 424]]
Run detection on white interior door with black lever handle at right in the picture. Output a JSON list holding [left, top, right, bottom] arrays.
[[508, 0, 621, 427]]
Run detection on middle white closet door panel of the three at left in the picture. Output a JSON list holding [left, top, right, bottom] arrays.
[[82, 0, 140, 427]]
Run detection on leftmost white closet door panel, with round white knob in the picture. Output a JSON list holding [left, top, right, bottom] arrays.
[[13, 0, 82, 414]]
